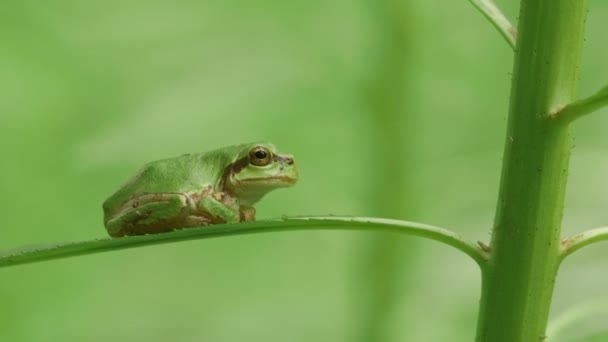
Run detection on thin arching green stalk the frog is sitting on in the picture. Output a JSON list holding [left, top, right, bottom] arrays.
[[0, 216, 487, 268]]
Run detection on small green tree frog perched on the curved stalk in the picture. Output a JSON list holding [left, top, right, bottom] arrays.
[[103, 143, 298, 237]]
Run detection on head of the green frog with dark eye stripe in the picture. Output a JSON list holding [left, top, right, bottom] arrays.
[[222, 143, 298, 206]]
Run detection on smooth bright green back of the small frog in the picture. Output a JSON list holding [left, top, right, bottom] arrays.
[[103, 150, 238, 211]]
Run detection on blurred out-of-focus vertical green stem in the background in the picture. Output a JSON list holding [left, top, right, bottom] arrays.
[[357, 0, 417, 342]]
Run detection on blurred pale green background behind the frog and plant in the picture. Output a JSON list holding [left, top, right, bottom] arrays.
[[0, 0, 608, 342]]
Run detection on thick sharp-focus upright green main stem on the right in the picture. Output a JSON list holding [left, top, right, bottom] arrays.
[[477, 0, 586, 342]]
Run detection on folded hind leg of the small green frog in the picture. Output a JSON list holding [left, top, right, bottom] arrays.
[[106, 193, 205, 237]]
